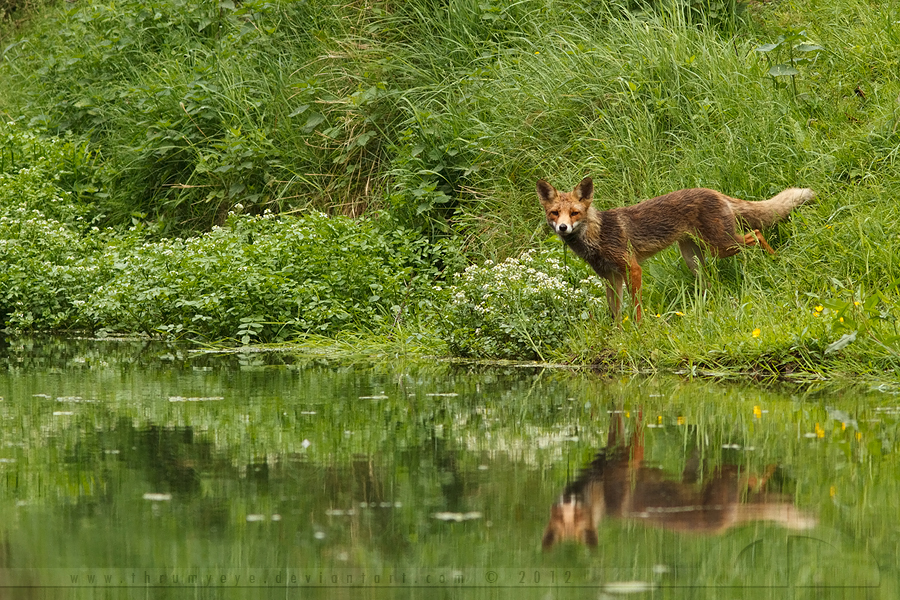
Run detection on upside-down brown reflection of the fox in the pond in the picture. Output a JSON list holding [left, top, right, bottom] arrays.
[[542, 411, 816, 550]]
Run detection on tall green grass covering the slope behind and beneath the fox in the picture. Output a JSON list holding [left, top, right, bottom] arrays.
[[0, 0, 900, 373]]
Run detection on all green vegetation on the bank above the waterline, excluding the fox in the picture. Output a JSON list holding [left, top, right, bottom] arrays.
[[0, 0, 900, 377]]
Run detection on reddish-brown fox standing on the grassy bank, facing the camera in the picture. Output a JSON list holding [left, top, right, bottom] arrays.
[[537, 177, 815, 321]]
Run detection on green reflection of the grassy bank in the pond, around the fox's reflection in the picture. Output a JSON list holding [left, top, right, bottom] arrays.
[[0, 342, 900, 598]]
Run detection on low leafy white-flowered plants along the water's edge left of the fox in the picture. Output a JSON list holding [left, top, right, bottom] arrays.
[[0, 119, 459, 343]]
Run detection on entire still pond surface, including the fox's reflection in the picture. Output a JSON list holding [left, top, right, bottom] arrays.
[[0, 339, 900, 599]]
